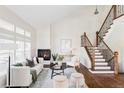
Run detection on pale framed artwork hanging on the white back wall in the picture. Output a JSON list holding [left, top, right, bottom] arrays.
[[61, 39, 71, 53]]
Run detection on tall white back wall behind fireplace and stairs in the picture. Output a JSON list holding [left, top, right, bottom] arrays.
[[37, 6, 111, 67]]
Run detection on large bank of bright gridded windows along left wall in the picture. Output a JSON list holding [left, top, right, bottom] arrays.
[[0, 19, 31, 72]]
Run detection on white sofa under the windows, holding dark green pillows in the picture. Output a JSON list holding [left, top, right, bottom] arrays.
[[7, 58, 43, 87]]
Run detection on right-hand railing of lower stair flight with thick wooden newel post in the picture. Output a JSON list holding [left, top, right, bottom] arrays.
[[98, 36, 118, 76]]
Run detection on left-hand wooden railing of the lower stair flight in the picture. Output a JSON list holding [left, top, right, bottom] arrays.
[[81, 32, 95, 70]]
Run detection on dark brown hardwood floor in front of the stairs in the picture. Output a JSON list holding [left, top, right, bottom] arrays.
[[76, 64, 124, 88]]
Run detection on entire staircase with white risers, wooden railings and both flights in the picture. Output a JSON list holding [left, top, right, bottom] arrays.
[[81, 5, 124, 76]]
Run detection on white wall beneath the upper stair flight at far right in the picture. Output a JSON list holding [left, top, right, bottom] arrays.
[[104, 17, 124, 72]]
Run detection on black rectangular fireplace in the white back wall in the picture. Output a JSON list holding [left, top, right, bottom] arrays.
[[38, 49, 51, 60]]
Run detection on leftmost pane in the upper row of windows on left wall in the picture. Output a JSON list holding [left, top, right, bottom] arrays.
[[0, 19, 14, 31]]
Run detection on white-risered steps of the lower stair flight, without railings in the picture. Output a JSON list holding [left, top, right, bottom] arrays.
[[89, 47, 114, 74]]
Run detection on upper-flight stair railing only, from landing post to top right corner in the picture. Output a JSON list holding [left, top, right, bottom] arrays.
[[96, 5, 124, 46]]
